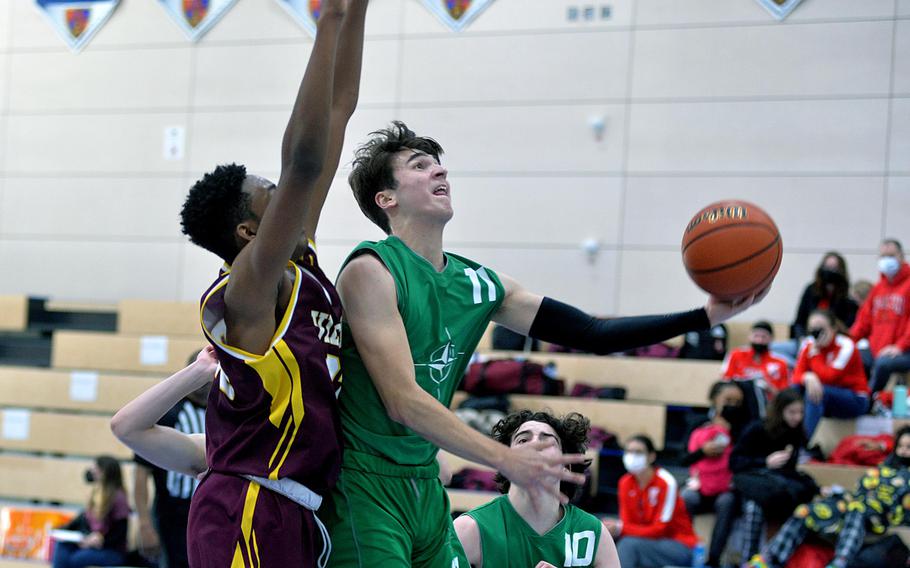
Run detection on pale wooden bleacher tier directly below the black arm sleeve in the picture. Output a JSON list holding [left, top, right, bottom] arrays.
[[478, 351, 720, 407]]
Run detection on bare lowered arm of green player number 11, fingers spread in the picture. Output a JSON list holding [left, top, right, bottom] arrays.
[[338, 255, 585, 502]]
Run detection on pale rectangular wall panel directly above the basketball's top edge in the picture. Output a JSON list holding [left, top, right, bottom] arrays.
[[629, 100, 887, 173]]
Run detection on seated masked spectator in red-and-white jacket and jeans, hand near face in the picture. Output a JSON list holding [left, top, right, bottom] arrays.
[[793, 310, 869, 439]]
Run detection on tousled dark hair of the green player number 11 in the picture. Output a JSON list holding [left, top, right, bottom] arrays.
[[348, 120, 443, 235]]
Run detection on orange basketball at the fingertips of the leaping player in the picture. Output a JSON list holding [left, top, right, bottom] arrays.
[[682, 200, 783, 301]]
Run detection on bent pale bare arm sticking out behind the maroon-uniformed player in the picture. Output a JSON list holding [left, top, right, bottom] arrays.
[[111, 346, 218, 476]]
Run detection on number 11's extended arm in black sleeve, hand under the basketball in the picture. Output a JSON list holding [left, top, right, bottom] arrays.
[[493, 275, 766, 355]]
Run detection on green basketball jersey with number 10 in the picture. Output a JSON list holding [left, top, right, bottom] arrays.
[[465, 495, 603, 568]]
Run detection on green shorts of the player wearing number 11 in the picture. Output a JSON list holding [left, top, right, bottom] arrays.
[[319, 449, 469, 568]]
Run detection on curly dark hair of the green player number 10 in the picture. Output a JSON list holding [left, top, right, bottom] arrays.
[[491, 410, 591, 499]]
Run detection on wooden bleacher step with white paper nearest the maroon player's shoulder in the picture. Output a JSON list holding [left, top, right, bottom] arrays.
[[51, 331, 206, 374]]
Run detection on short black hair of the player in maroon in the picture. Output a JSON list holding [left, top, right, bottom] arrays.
[[180, 164, 255, 263]]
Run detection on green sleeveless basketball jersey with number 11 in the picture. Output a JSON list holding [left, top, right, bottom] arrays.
[[338, 236, 505, 465]]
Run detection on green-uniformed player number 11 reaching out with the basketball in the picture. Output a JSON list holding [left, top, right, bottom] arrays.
[[321, 122, 757, 568]]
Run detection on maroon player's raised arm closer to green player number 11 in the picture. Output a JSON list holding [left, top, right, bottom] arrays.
[[302, 0, 369, 236]]
